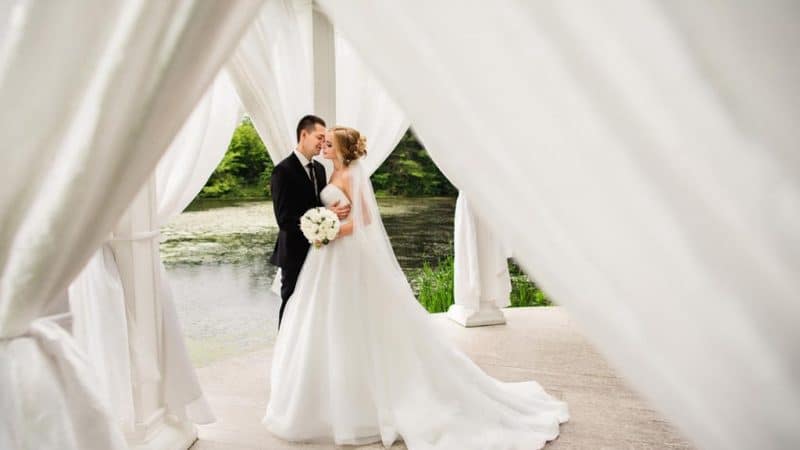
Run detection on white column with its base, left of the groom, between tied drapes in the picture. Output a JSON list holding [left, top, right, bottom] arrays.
[[111, 176, 197, 450]]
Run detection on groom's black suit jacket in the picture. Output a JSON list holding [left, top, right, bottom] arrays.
[[270, 152, 327, 269]]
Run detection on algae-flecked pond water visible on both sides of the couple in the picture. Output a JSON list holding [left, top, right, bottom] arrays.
[[161, 197, 455, 366]]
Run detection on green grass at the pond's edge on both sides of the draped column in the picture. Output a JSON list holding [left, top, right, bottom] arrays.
[[414, 255, 552, 313]]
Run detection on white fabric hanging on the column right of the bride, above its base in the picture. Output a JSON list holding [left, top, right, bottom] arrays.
[[453, 194, 511, 311]]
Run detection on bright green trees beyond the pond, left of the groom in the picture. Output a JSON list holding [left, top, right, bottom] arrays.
[[200, 117, 273, 198]]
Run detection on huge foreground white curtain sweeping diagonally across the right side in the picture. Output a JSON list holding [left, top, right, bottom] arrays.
[[320, 0, 800, 449]]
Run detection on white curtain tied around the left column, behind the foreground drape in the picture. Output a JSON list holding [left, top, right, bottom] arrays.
[[69, 71, 241, 429]]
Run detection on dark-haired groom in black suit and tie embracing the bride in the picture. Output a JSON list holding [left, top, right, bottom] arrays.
[[270, 115, 350, 329]]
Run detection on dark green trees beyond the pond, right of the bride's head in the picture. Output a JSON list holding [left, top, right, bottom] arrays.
[[372, 130, 458, 197]]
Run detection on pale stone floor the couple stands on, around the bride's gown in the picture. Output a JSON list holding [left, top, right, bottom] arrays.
[[192, 307, 692, 450]]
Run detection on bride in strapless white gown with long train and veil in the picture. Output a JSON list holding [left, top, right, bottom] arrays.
[[263, 127, 569, 450]]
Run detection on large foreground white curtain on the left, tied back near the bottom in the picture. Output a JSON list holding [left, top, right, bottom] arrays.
[[0, 0, 259, 449]]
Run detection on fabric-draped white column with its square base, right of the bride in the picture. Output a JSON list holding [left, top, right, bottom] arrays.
[[447, 193, 511, 327]]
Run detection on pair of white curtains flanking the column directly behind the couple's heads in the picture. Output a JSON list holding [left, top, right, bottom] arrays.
[[227, 0, 408, 172]]
